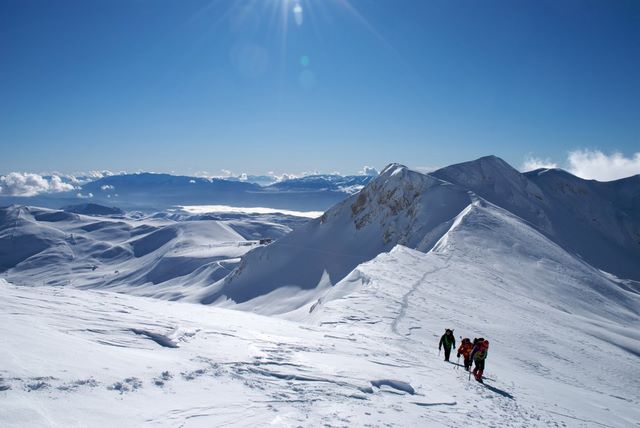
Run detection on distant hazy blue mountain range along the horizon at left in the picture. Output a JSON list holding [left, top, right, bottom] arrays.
[[0, 173, 373, 211]]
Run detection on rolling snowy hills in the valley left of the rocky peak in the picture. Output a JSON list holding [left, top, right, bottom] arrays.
[[0, 206, 290, 299]]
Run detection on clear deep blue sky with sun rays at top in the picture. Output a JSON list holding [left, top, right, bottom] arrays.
[[0, 0, 640, 174]]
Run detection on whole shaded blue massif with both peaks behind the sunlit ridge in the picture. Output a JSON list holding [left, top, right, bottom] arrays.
[[200, 156, 640, 313]]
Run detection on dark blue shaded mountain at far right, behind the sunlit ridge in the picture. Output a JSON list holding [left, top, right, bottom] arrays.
[[432, 156, 640, 280]]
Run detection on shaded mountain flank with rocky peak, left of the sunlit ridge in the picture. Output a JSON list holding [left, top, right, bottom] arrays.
[[198, 164, 470, 313]]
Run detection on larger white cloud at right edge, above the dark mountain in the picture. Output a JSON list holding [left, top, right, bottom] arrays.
[[567, 150, 640, 181]]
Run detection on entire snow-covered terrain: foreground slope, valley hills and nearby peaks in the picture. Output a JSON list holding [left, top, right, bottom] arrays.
[[0, 157, 640, 427]]
